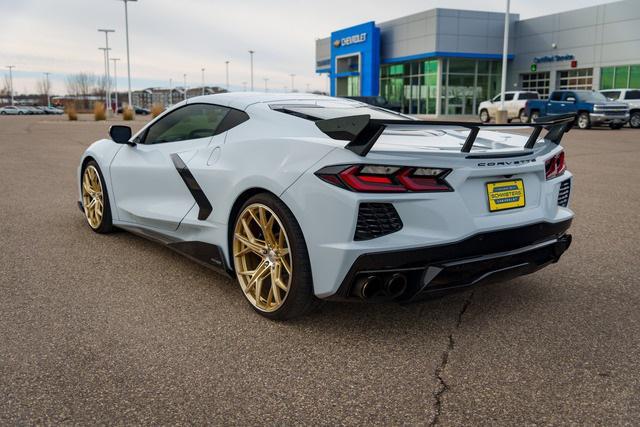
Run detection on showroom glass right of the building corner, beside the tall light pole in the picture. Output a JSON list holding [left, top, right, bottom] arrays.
[[440, 58, 502, 115]]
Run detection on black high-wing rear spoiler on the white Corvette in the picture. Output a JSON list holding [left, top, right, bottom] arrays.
[[316, 114, 576, 157]]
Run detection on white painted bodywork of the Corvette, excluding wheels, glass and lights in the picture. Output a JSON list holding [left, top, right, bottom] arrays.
[[78, 93, 573, 298]]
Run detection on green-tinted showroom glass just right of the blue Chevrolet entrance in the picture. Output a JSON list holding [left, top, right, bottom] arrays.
[[380, 59, 439, 114]]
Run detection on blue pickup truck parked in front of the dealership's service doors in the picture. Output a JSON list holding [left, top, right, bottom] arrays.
[[525, 90, 629, 129]]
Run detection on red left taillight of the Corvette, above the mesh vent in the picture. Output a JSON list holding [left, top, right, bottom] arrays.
[[316, 165, 453, 193]]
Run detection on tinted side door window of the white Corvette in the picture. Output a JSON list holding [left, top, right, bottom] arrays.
[[144, 104, 229, 144]]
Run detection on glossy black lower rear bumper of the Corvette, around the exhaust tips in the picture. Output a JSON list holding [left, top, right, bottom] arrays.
[[328, 220, 571, 302]]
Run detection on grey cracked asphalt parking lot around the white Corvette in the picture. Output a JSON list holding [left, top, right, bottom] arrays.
[[0, 116, 640, 425]]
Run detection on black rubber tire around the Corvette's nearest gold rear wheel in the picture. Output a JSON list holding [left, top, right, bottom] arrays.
[[230, 193, 322, 320]]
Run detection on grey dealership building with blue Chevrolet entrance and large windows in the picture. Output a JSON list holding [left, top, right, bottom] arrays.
[[316, 0, 640, 115]]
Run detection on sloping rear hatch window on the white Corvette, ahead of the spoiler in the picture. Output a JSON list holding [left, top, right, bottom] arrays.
[[269, 100, 415, 121]]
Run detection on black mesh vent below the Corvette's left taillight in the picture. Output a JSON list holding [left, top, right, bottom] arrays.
[[354, 203, 402, 240]]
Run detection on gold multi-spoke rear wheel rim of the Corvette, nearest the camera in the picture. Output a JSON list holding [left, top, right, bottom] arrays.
[[233, 203, 292, 312]]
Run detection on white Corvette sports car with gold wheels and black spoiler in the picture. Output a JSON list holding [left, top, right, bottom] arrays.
[[78, 93, 574, 319]]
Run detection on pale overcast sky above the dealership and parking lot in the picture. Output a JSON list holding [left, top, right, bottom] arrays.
[[0, 0, 620, 93]]
